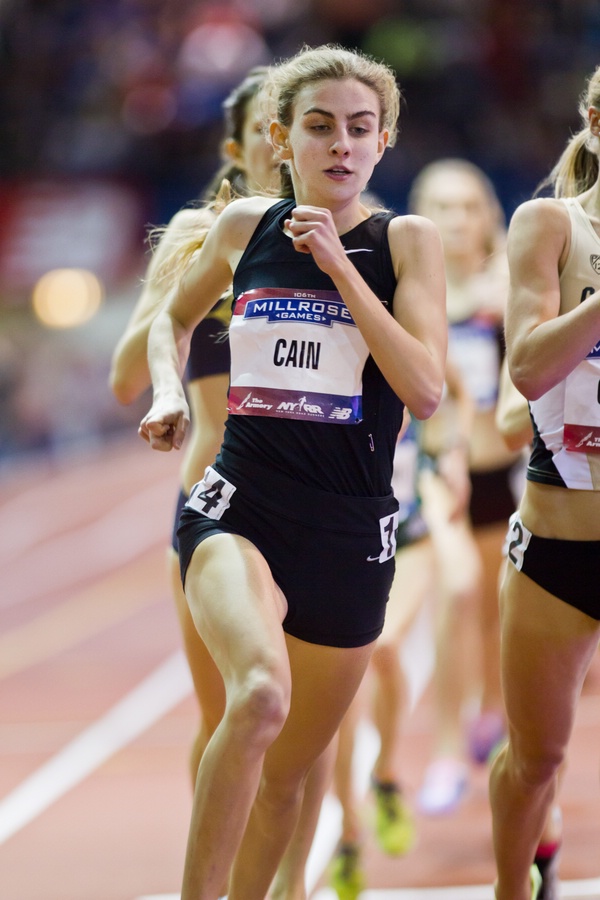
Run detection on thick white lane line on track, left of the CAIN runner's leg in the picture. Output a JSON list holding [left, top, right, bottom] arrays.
[[0, 650, 192, 844]]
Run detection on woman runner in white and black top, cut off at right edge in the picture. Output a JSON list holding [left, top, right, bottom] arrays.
[[490, 67, 600, 900]]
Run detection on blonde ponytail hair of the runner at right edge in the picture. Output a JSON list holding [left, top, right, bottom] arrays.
[[535, 66, 600, 197]]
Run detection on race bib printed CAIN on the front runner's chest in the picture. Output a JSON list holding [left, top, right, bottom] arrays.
[[229, 288, 369, 425]]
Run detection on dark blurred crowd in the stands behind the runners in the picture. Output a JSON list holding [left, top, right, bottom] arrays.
[[0, 0, 600, 463]]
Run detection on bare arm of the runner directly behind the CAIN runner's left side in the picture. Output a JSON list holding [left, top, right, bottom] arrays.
[[109, 209, 214, 403]]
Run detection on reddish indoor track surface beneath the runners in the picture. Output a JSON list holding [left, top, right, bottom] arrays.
[[0, 435, 600, 900]]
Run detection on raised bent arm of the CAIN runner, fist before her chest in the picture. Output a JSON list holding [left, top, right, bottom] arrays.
[[290, 206, 448, 419]]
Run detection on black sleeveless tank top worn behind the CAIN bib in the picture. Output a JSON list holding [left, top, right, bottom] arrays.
[[221, 200, 404, 497]]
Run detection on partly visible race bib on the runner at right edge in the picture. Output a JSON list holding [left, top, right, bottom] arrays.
[[563, 344, 600, 453]]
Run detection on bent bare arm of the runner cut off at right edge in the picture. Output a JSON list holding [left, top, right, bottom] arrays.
[[506, 200, 600, 400]]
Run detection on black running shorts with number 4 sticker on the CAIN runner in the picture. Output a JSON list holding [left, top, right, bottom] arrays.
[[178, 460, 398, 647]]
